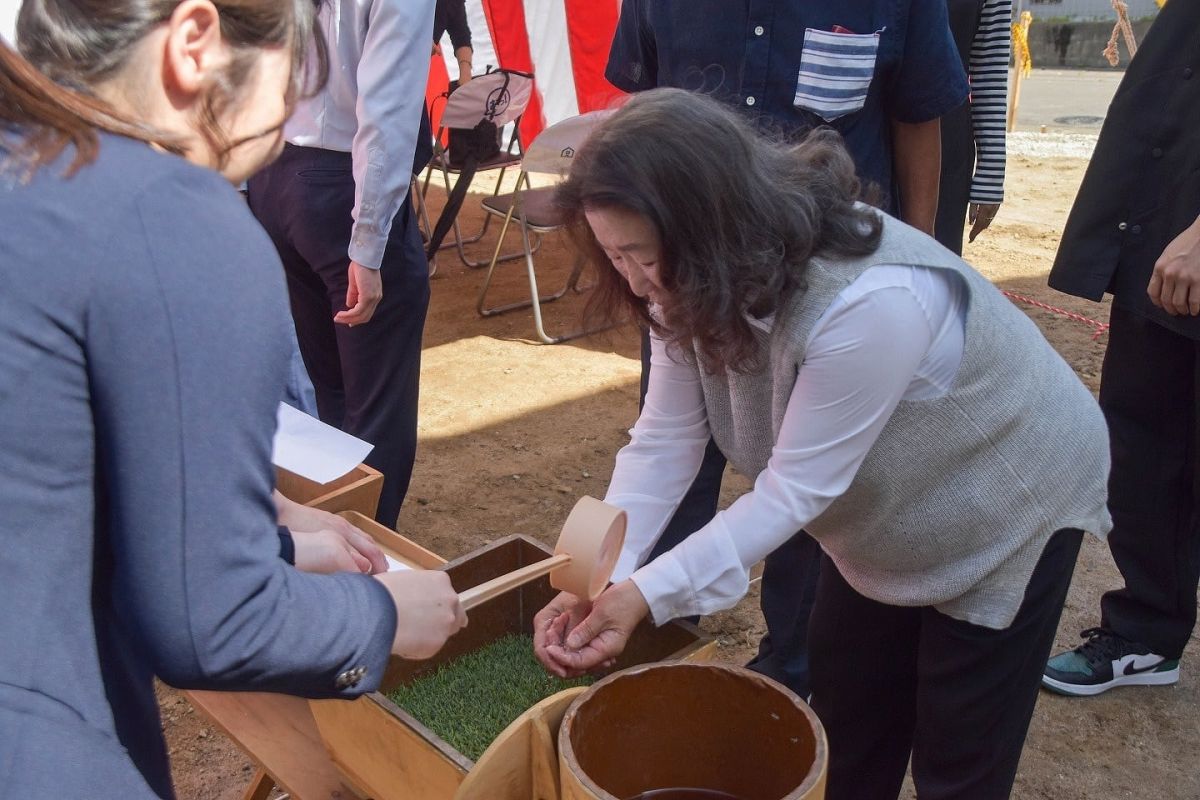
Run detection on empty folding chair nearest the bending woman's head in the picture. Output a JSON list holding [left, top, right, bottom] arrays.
[[475, 110, 612, 344]]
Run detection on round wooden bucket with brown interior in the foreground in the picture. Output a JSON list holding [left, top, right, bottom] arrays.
[[558, 663, 828, 800]]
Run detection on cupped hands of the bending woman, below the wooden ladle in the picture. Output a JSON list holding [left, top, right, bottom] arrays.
[[533, 581, 650, 678]]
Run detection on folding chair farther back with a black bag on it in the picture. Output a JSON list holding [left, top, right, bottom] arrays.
[[421, 70, 533, 267]]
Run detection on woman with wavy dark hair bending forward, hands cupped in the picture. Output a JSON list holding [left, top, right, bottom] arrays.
[[535, 90, 1110, 799]]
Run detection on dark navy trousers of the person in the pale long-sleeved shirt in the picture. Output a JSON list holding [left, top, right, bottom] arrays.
[[248, 145, 430, 527]]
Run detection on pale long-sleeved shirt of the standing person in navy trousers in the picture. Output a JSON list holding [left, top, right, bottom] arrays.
[[284, 0, 434, 270]]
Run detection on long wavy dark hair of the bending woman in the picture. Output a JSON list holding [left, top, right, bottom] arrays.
[[557, 89, 882, 374]]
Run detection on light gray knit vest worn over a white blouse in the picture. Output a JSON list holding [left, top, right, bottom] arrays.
[[701, 217, 1112, 628]]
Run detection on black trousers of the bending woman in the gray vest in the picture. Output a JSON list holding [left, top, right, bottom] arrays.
[[809, 530, 1082, 800]]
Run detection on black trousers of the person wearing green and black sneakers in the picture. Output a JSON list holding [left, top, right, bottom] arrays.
[[1100, 306, 1200, 658]]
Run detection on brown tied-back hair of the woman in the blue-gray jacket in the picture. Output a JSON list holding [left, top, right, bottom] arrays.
[[0, 0, 329, 174]]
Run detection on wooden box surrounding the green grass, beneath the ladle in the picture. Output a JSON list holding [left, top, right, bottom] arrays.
[[311, 531, 716, 800]]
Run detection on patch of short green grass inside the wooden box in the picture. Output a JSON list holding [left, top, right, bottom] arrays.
[[388, 633, 594, 762]]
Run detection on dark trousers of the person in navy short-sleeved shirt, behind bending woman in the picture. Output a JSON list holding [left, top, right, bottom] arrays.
[[642, 332, 821, 697]]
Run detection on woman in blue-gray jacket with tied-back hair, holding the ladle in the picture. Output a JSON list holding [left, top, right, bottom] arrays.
[[0, 0, 466, 800]]
